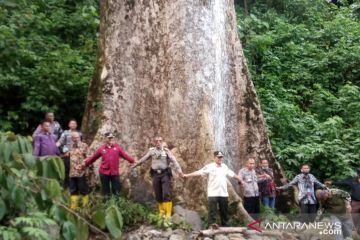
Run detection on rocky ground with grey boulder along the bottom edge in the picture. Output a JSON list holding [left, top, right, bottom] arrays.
[[123, 206, 360, 240]]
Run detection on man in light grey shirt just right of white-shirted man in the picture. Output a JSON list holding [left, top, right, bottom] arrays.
[[238, 158, 269, 219]]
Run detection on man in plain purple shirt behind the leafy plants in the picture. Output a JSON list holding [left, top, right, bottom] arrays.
[[33, 120, 60, 157]]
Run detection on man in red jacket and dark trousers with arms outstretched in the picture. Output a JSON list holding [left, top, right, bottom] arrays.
[[78, 132, 135, 199]]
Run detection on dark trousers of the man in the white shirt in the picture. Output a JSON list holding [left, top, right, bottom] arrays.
[[208, 197, 228, 226]]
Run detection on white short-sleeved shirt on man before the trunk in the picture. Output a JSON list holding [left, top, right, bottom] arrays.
[[199, 163, 235, 197]]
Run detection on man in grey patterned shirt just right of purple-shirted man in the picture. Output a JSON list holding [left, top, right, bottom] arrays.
[[56, 119, 81, 187]]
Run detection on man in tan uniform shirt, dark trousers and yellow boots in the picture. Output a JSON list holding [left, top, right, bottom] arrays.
[[134, 137, 183, 218]]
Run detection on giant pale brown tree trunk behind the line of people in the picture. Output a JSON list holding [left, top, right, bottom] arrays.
[[82, 0, 281, 221]]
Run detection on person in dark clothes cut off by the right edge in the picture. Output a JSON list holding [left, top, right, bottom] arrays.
[[334, 168, 360, 234]]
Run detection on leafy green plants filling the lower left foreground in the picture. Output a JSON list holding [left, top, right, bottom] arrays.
[[0, 132, 159, 240]]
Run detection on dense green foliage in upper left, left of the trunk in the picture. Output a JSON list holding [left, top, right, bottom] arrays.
[[0, 0, 99, 133]]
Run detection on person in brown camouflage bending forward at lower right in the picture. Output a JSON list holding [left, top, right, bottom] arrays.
[[316, 188, 353, 240]]
